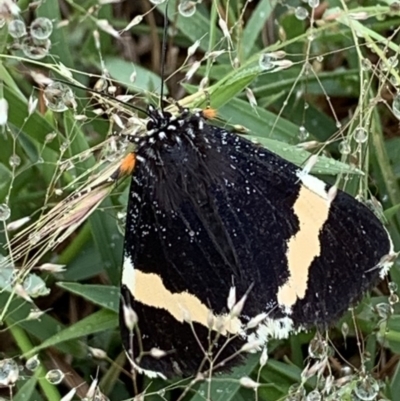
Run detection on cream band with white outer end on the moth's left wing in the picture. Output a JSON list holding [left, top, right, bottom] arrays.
[[122, 256, 242, 335]]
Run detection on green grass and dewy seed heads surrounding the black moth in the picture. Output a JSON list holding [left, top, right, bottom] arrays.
[[0, 0, 400, 401]]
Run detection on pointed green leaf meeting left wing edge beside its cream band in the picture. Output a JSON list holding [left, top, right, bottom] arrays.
[[57, 282, 119, 312]]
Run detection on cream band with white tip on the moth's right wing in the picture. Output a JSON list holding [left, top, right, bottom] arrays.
[[277, 175, 329, 311]]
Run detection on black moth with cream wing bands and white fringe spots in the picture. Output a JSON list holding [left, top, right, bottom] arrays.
[[120, 107, 394, 378]]
